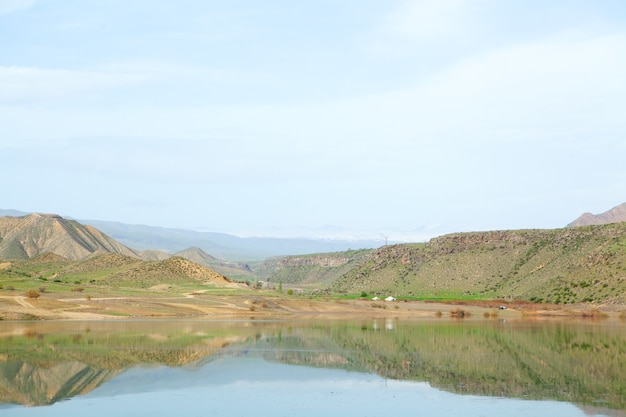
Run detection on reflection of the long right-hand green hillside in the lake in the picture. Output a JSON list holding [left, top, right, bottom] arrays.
[[224, 322, 626, 410]]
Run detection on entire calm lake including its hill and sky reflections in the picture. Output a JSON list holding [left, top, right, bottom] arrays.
[[0, 318, 626, 417]]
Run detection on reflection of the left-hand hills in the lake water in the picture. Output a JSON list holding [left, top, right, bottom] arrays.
[[0, 322, 254, 405]]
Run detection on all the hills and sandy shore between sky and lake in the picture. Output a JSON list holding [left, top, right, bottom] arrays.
[[0, 204, 626, 320]]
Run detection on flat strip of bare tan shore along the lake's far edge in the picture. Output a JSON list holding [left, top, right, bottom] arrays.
[[0, 293, 626, 322]]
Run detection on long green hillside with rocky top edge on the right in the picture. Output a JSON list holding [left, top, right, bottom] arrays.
[[328, 223, 626, 304]]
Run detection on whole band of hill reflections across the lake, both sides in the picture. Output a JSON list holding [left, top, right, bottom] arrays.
[[0, 321, 626, 410]]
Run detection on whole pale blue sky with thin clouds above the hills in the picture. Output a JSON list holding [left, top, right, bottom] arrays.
[[0, 0, 626, 241]]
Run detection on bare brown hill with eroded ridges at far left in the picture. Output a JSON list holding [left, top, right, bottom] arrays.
[[0, 213, 138, 260]]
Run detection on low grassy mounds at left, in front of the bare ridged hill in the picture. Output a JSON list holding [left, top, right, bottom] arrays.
[[0, 250, 240, 308]]
